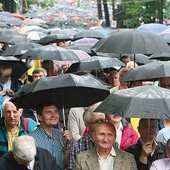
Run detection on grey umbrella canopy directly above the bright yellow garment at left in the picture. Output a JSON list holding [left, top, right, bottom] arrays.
[[21, 45, 80, 61]]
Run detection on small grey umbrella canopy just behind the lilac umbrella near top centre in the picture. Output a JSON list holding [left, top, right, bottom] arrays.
[[73, 30, 104, 40]]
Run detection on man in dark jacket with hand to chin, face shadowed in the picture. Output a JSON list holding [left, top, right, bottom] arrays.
[[125, 119, 166, 170]]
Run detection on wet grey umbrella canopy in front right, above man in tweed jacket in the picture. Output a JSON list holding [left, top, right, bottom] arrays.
[[95, 85, 170, 119]]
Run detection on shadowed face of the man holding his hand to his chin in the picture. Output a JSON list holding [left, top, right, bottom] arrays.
[[138, 120, 158, 142]]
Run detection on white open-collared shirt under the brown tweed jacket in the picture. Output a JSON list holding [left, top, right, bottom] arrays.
[[97, 147, 116, 170]]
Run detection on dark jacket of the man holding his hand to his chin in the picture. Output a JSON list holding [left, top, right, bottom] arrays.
[[125, 140, 166, 170]]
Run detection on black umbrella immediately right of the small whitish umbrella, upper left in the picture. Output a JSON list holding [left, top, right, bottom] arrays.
[[38, 34, 72, 45]]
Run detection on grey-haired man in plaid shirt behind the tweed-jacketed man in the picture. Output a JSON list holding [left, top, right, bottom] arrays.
[[67, 105, 105, 170]]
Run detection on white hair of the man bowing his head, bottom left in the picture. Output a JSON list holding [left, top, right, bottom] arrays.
[[12, 135, 36, 161]]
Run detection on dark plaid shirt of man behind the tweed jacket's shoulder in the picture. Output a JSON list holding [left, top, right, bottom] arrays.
[[68, 134, 95, 170]]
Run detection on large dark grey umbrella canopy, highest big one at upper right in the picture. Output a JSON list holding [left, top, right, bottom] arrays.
[[95, 30, 170, 54]]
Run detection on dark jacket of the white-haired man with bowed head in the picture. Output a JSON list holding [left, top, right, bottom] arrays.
[[0, 147, 59, 170]]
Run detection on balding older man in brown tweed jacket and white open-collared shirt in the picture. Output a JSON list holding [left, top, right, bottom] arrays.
[[74, 122, 137, 170]]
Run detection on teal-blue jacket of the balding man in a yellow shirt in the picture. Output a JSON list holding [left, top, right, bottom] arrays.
[[0, 117, 37, 157]]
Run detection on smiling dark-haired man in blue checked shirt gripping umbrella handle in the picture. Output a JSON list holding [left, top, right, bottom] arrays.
[[30, 101, 72, 170]]
